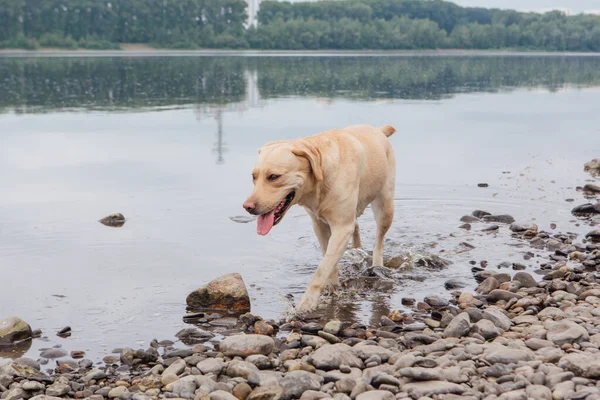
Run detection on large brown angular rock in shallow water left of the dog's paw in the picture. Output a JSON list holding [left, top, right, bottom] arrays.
[[186, 274, 250, 313]]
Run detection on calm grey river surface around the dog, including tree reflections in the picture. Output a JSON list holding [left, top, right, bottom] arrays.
[[0, 56, 600, 358]]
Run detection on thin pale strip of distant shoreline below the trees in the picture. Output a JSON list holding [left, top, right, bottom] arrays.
[[0, 46, 600, 57]]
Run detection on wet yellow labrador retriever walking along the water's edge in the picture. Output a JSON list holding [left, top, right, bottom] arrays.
[[243, 125, 396, 312]]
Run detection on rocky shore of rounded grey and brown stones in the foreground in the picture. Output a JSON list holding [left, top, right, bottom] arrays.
[[0, 161, 600, 400]]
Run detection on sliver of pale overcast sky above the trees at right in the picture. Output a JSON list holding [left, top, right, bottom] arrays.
[[451, 0, 600, 13]]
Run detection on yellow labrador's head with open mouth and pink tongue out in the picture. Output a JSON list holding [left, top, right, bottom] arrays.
[[243, 141, 323, 235]]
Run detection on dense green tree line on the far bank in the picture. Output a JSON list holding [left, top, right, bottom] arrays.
[[0, 0, 600, 51]]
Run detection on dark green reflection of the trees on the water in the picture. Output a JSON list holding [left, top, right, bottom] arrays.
[[0, 56, 600, 113]]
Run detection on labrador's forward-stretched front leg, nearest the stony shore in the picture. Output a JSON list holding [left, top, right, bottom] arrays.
[[298, 223, 354, 312]]
